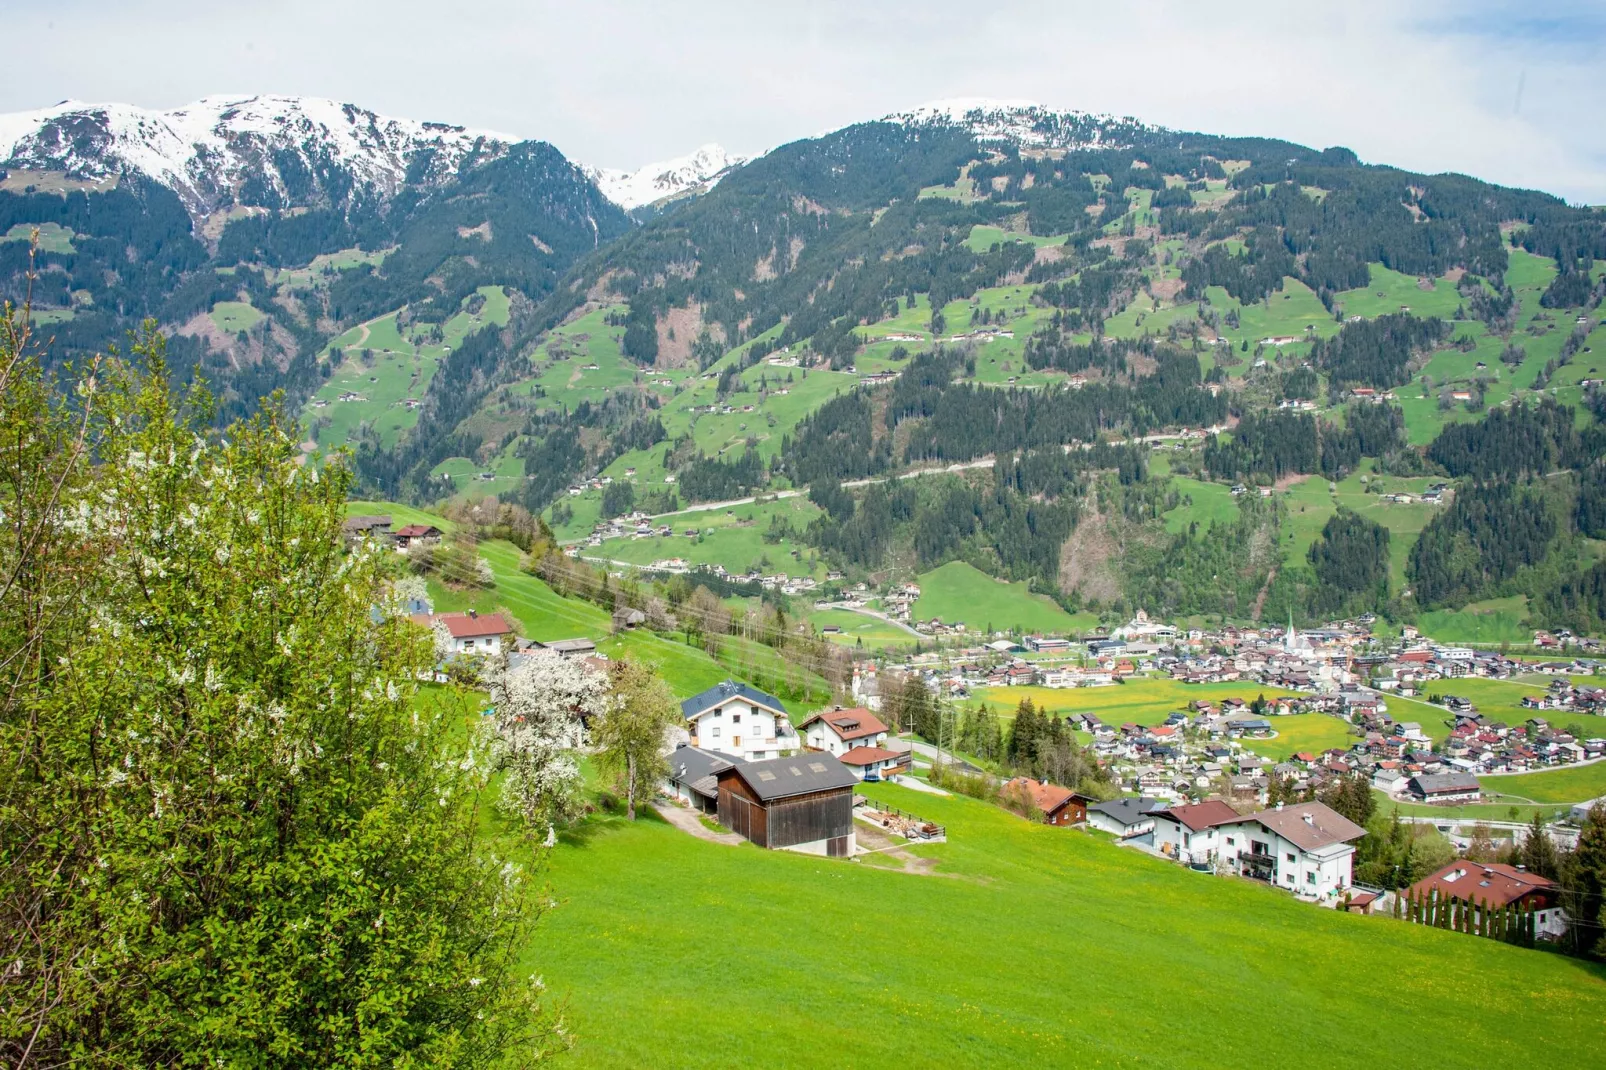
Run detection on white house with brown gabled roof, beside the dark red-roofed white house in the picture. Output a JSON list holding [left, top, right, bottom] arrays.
[[1219, 802, 1367, 900]]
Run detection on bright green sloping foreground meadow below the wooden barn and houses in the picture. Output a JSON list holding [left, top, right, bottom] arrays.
[[528, 784, 1606, 1068]]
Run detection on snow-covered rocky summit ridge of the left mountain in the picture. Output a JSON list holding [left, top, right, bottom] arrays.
[[0, 95, 519, 215]]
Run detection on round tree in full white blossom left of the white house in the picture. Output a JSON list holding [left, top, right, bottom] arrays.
[[490, 651, 609, 827]]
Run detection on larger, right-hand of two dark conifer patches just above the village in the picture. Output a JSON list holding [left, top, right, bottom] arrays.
[[1405, 482, 1558, 609]]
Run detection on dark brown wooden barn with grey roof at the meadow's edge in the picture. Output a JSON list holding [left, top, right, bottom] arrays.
[[716, 753, 858, 858]]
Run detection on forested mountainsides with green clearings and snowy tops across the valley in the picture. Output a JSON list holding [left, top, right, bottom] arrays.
[[0, 101, 1606, 628]]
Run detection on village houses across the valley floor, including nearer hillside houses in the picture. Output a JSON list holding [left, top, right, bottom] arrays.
[[347, 516, 1606, 943]]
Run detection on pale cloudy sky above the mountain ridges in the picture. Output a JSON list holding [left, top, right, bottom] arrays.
[[0, 0, 1606, 204]]
